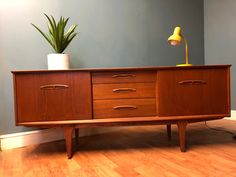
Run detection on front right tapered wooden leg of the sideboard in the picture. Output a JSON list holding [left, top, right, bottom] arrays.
[[177, 121, 187, 152]]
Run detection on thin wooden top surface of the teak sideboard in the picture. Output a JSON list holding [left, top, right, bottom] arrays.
[[11, 65, 231, 74]]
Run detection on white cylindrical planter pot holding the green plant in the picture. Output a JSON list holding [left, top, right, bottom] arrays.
[[47, 53, 70, 70]]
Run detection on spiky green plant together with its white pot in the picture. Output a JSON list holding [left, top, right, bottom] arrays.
[[31, 14, 78, 70]]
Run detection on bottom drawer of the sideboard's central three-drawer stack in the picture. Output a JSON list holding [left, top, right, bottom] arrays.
[[93, 99, 156, 119]]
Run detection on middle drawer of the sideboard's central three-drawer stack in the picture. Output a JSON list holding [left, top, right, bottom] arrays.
[[93, 83, 156, 100]]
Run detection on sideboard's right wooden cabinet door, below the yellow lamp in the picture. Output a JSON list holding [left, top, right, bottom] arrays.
[[157, 68, 230, 116]]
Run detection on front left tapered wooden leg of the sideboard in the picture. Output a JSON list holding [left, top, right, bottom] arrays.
[[64, 126, 74, 159]]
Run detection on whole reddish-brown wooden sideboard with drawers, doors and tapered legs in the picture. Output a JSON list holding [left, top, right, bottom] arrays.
[[12, 65, 230, 158]]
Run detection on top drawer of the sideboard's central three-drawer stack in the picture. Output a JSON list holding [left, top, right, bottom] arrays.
[[92, 71, 156, 84]]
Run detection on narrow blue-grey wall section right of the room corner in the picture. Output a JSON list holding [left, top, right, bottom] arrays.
[[204, 0, 236, 109]]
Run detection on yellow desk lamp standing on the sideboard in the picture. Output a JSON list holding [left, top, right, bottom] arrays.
[[168, 27, 192, 66]]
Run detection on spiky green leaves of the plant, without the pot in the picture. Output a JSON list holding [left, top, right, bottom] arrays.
[[31, 14, 78, 53]]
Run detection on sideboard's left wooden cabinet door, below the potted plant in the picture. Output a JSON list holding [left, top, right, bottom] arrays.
[[14, 72, 92, 123]]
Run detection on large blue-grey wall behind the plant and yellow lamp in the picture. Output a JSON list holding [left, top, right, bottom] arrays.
[[0, 0, 204, 134]]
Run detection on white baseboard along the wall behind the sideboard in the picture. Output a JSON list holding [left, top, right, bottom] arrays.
[[0, 110, 236, 151]]
